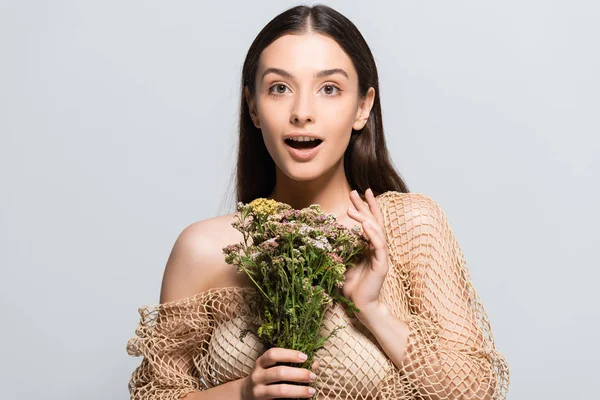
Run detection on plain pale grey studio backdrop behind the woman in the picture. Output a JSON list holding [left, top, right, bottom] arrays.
[[0, 0, 600, 400]]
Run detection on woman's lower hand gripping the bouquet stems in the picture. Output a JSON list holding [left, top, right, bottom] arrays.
[[241, 347, 319, 400]]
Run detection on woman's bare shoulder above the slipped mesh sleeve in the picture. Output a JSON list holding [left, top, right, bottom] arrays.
[[160, 212, 243, 303]]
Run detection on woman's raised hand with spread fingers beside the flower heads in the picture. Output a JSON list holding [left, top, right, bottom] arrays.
[[342, 189, 389, 320]]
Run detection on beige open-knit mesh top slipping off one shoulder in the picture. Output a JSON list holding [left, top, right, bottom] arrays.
[[127, 191, 510, 400]]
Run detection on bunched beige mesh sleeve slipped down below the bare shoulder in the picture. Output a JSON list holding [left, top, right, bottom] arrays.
[[127, 292, 214, 400]]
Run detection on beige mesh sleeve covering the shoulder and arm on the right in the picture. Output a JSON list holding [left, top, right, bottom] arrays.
[[385, 192, 509, 400]]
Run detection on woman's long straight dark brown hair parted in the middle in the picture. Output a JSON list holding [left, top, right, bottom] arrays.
[[227, 4, 409, 209]]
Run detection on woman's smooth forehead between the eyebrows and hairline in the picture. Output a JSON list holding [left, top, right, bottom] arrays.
[[257, 33, 357, 80]]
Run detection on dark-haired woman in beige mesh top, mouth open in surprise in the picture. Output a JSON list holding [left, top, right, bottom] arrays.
[[127, 5, 509, 400]]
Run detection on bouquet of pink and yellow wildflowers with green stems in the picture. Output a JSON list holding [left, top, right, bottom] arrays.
[[223, 198, 368, 383]]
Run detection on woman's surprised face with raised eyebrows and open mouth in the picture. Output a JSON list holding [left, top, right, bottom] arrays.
[[246, 33, 375, 181]]
